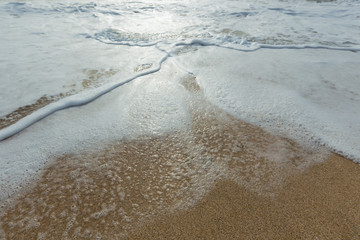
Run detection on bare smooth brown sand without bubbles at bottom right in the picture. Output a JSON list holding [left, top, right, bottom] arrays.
[[129, 155, 360, 239]]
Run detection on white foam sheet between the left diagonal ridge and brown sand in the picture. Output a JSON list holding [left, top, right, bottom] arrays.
[[0, 59, 189, 199]]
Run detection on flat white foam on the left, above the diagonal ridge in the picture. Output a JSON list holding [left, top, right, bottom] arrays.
[[0, 35, 162, 116]]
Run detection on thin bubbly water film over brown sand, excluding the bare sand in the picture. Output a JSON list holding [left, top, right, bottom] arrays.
[[1, 74, 326, 239]]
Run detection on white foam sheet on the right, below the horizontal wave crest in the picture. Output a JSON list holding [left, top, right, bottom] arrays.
[[178, 47, 360, 161]]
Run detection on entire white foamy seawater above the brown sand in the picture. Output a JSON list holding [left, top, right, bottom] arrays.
[[0, 0, 360, 201]]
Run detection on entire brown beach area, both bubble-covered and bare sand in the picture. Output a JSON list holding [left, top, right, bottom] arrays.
[[0, 76, 360, 239]]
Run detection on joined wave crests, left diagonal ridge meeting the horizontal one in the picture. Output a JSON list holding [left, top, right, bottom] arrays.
[[0, 34, 360, 141]]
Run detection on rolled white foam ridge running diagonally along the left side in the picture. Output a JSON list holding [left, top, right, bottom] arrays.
[[0, 50, 169, 141]]
